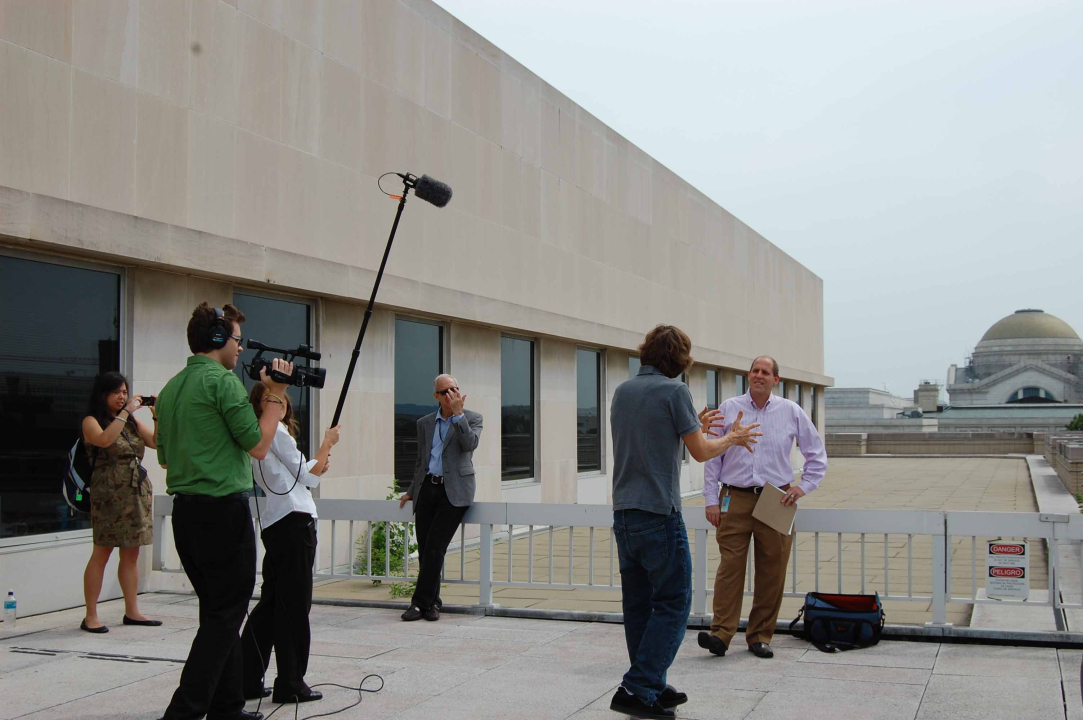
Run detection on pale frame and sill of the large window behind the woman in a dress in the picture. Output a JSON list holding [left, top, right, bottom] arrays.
[[0, 246, 127, 547]]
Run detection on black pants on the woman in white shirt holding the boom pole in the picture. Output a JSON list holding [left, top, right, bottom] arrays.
[[240, 512, 316, 697]]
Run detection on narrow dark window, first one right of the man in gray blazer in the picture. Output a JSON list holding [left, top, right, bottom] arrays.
[[500, 338, 534, 480]]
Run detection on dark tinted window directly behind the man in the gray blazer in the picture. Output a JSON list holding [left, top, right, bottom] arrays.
[[394, 317, 444, 489]]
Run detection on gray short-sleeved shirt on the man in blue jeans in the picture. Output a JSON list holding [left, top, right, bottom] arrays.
[[610, 365, 700, 515]]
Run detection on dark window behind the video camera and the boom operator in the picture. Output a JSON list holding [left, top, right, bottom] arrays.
[[233, 292, 309, 457]]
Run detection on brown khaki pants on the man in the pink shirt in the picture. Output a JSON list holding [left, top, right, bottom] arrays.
[[710, 488, 794, 647]]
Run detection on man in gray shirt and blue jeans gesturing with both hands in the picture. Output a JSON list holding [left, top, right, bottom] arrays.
[[610, 325, 760, 718]]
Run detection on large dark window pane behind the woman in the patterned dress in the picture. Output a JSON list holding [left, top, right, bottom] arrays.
[[0, 256, 119, 537]]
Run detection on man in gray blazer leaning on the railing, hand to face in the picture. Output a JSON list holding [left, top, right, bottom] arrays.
[[399, 375, 482, 620]]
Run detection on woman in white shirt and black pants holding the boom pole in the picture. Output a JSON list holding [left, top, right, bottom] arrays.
[[240, 382, 341, 703]]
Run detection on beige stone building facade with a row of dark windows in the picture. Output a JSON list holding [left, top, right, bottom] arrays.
[[0, 0, 832, 612]]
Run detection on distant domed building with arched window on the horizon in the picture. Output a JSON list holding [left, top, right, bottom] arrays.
[[948, 310, 1083, 408]]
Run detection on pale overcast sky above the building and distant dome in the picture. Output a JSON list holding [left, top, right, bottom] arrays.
[[438, 0, 1083, 396]]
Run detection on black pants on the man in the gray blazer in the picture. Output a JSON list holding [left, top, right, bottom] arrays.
[[412, 476, 467, 611]]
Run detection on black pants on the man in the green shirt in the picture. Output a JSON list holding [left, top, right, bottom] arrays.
[[164, 495, 256, 720]]
